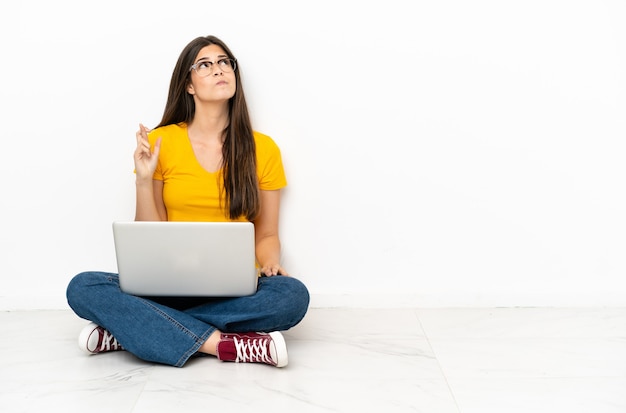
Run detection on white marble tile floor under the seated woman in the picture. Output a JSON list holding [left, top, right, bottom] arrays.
[[0, 308, 626, 413]]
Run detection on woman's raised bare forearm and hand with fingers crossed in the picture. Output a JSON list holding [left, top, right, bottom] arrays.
[[133, 124, 167, 221]]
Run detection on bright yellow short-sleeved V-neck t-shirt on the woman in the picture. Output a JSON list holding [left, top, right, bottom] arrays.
[[148, 123, 287, 221]]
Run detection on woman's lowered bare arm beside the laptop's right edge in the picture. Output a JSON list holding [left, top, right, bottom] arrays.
[[254, 190, 289, 277]]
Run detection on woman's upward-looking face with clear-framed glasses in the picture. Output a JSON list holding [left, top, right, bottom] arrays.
[[187, 44, 237, 103]]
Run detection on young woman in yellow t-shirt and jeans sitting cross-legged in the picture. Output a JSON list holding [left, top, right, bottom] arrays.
[[67, 36, 309, 367]]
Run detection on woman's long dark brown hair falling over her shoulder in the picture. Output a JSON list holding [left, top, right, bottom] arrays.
[[156, 36, 260, 221]]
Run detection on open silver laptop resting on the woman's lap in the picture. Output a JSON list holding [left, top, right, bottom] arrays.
[[113, 221, 258, 297]]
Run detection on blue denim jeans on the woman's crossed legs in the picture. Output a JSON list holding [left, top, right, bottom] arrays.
[[67, 272, 309, 367]]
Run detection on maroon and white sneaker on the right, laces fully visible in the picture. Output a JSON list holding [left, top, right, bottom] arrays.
[[217, 331, 289, 367]]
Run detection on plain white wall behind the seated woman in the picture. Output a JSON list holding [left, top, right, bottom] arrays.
[[0, 0, 626, 309]]
